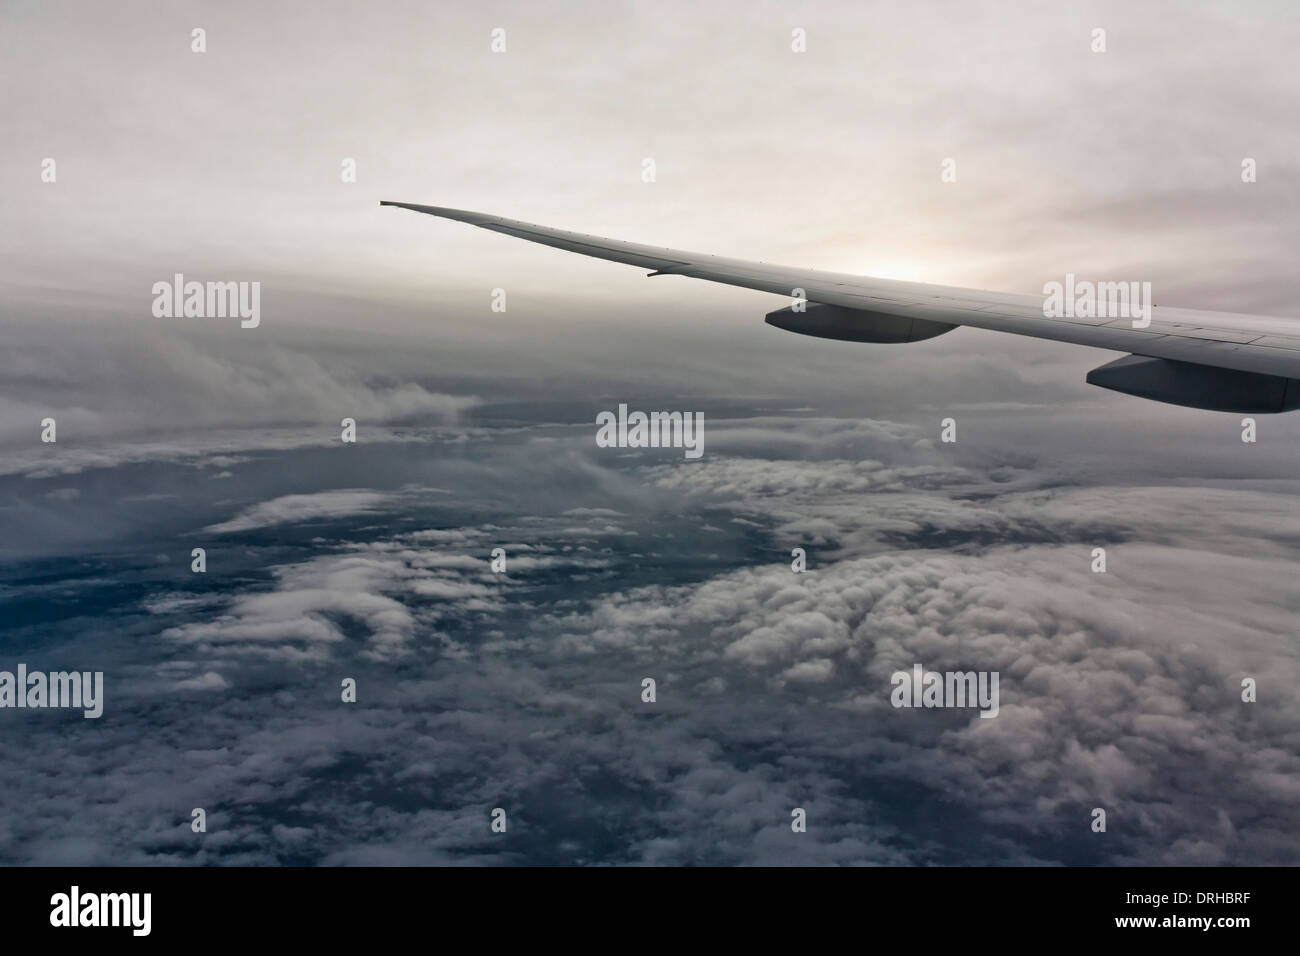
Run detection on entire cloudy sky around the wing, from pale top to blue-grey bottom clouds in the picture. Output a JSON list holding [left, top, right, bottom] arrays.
[[0, 1, 1300, 865]]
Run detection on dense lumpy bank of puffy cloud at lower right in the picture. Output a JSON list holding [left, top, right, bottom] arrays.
[[543, 546, 1300, 864]]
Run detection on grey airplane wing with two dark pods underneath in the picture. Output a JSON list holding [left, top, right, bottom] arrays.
[[380, 202, 1300, 412]]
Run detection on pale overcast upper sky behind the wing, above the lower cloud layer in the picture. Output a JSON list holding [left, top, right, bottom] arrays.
[[0, 3, 1300, 444]]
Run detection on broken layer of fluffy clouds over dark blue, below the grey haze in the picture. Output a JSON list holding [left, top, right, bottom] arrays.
[[0, 416, 1300, 864]]
